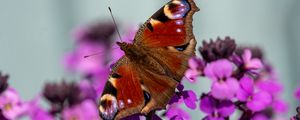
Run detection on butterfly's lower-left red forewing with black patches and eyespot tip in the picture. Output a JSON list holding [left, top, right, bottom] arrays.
[[99, 57, 145, 119]]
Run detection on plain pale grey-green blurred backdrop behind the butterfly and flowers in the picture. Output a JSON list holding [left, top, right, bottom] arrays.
[[0, 0, 300, 118]]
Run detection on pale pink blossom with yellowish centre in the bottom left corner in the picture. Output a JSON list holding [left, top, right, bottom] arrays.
[[0, 88, 26, 119]]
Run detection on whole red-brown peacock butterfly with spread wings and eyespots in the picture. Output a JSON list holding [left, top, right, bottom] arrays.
[[98, 0, 199, 120]]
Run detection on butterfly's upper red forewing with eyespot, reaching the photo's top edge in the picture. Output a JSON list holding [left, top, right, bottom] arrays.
[[135, 0, 199, 47]]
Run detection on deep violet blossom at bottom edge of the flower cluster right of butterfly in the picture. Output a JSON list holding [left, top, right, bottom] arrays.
[[200, 95, 235, 120]]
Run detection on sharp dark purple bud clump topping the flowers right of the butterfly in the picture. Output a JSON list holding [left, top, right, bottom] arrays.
[[199, 37, 236, 62]]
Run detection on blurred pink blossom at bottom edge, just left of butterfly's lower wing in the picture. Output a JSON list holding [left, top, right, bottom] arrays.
[[62, 100, 100, 120]]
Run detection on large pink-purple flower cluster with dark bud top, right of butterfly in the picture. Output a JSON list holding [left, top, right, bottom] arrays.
[[168, 37, 288, 120]]
